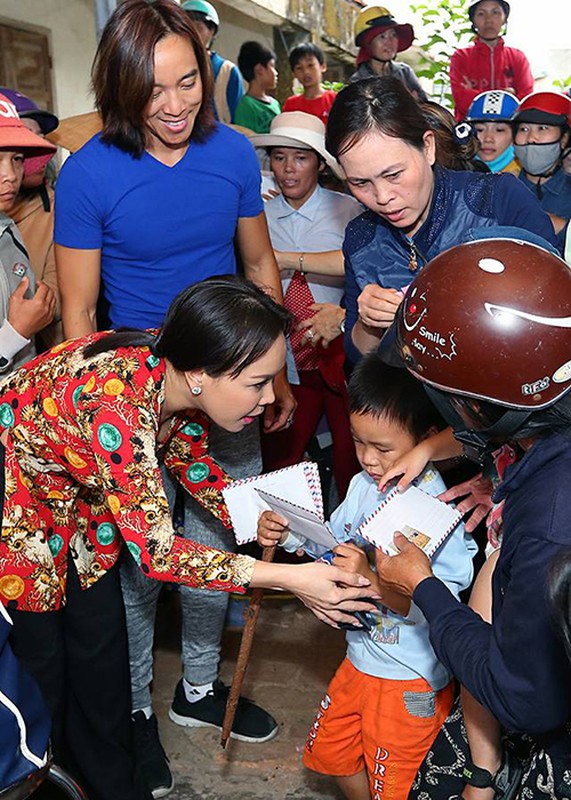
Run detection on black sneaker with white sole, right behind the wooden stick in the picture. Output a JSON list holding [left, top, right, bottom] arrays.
[[169, 680, 278, 742]]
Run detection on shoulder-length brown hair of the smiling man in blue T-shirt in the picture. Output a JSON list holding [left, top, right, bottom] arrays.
[[91, 0, 215, 158]]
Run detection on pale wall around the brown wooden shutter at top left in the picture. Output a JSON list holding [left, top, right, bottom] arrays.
[[0, 0, 96, 118]]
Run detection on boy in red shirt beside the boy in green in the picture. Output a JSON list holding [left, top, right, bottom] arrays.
[[283, 42, 337, 125]]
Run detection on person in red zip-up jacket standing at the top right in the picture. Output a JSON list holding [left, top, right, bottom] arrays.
[[450, 0, 533, 120]]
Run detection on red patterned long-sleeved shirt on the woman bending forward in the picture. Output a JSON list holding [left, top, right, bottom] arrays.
[[0, 334, 254, 611]]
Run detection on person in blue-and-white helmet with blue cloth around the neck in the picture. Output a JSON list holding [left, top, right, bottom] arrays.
[[466, 89, 521, 175]]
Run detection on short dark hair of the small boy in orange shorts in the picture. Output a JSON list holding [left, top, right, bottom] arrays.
[[349, 353, 446, 441]]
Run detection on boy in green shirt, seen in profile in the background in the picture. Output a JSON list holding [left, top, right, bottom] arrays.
[[234, 42, 281, 133]]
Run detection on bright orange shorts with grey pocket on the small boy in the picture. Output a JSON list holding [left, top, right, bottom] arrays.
[[303, 658, 454, 800]]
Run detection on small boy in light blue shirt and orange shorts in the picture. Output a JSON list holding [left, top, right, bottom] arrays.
[[258, 353, 477, 800]]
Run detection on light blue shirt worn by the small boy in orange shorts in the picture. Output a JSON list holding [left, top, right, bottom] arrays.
[[284, 465, 478, 691]]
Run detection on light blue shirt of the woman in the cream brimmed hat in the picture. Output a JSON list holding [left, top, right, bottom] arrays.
[[264, 186, 363, 383]]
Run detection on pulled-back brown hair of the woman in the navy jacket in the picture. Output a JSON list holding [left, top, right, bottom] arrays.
[[325, 76, 430, 159]]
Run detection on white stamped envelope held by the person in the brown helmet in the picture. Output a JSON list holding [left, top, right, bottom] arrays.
[[359, 486, 462, 558]]
